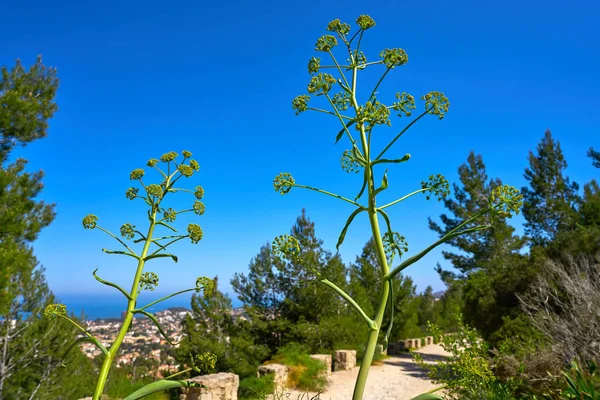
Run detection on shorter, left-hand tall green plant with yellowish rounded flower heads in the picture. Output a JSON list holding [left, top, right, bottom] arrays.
[[45, 151, 215, 400]]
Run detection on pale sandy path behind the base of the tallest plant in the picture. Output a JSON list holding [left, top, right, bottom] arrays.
[[276, 345, 448, 400]]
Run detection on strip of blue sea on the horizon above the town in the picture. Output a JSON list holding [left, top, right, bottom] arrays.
[[55, 292, 240, 320]]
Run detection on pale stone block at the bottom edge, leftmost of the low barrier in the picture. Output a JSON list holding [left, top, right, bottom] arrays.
[[179, 372, 240, 400]]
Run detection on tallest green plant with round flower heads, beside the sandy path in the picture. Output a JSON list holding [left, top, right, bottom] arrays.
[[273, 15, 522, 400]]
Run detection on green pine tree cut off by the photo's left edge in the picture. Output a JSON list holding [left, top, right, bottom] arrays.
[[0, 58, 91, 400]]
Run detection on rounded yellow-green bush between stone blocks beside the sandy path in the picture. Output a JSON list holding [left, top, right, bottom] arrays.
[[272, 342, 327, 392]]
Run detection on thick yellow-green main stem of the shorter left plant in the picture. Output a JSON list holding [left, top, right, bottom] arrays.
[[93, 211, 156, 400]]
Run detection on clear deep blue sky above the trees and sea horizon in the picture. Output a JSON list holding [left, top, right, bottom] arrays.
[[0, 0, 600, 300]]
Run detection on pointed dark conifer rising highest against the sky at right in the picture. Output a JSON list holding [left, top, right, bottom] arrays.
[[521, 130, 578, 246]]
